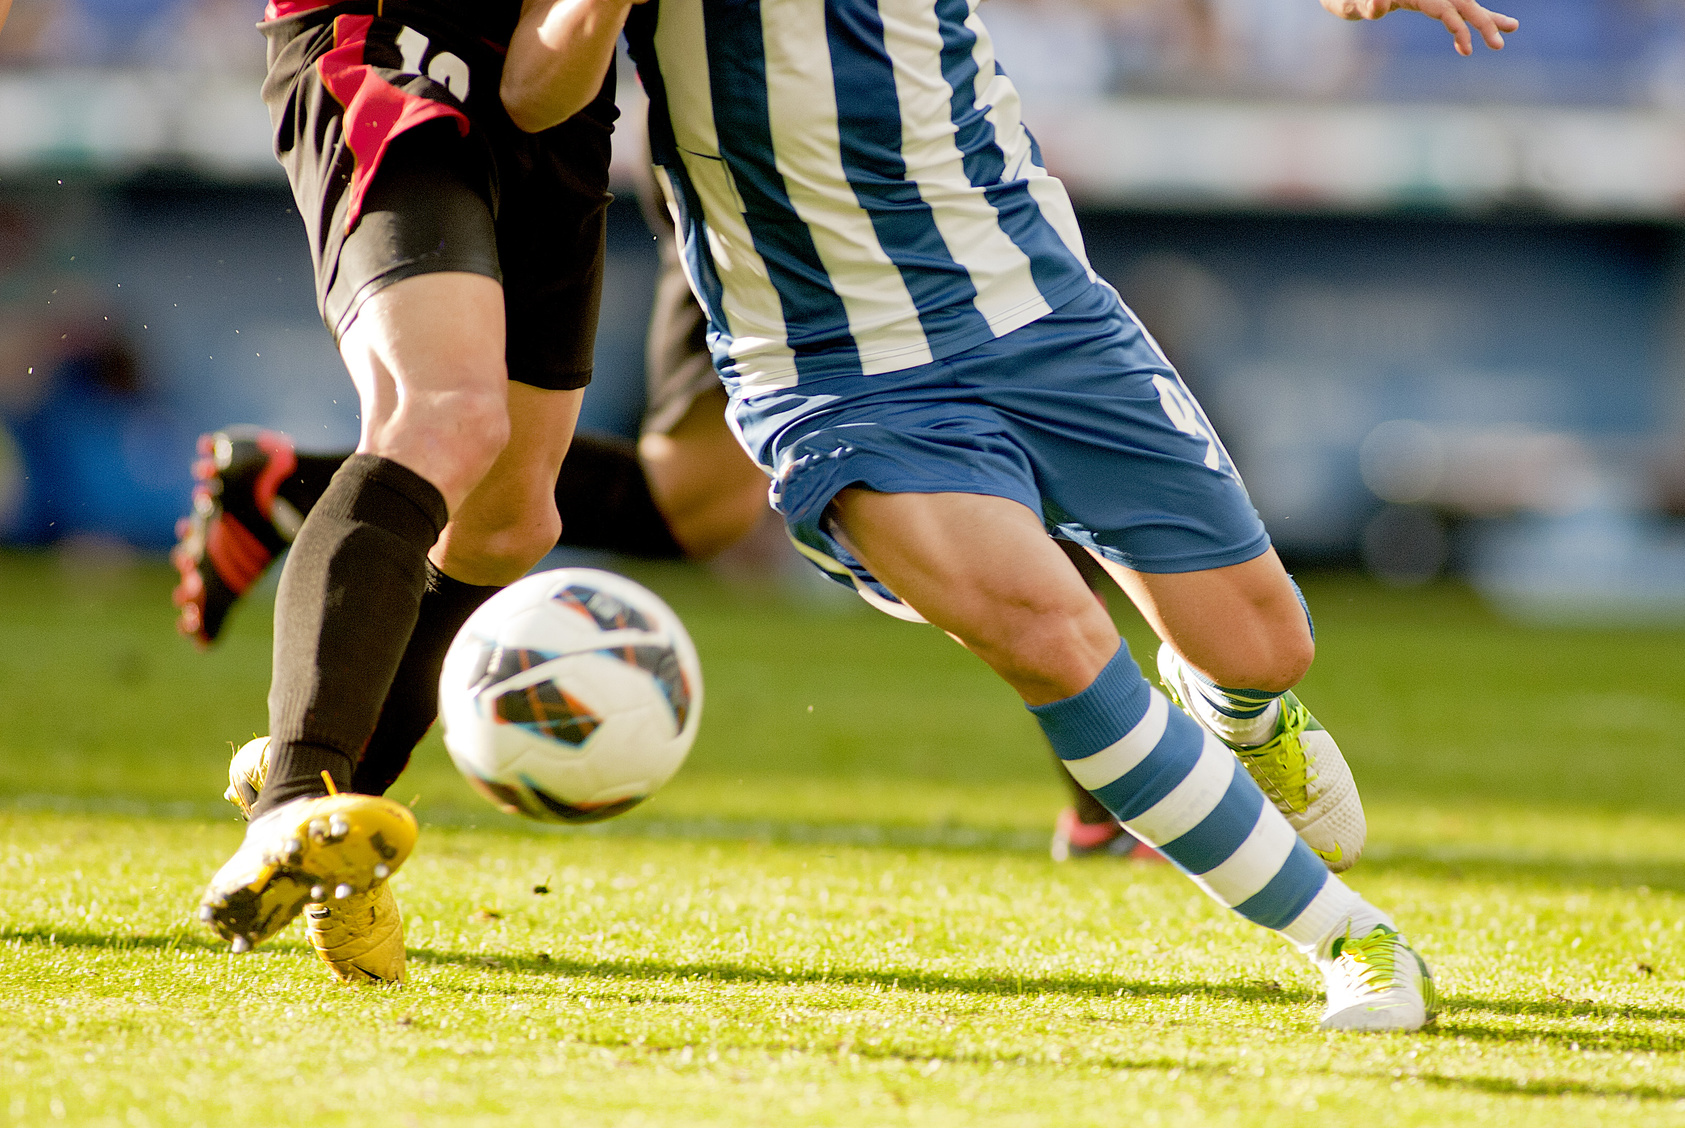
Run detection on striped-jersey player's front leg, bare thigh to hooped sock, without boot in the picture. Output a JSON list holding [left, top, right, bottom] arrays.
[[831, 489, 1383, 951]]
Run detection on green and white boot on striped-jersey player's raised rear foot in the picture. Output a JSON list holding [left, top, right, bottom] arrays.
[[1158, 642, 1368, 873]]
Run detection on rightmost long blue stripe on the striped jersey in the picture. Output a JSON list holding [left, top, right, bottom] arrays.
[[935, 0, 1089, 307]]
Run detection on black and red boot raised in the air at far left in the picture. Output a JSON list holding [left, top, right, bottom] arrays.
[[170, 427, 303, 646]]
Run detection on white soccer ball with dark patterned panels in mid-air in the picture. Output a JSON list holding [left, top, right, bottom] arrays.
[[438, 568, 703, 823]]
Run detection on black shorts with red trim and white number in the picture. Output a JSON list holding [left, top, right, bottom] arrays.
[[263, 0, 615, 389]]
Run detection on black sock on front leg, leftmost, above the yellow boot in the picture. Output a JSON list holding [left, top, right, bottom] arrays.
[[253, 454, 448, 816]]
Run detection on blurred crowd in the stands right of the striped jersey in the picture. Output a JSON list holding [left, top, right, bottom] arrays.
[[984, 0, 1685, 108]]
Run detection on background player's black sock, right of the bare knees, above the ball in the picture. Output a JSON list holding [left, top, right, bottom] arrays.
[[556, 435, 684, 560]]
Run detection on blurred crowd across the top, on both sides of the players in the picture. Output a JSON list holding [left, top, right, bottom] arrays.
[[0, 0, 1685, 108]]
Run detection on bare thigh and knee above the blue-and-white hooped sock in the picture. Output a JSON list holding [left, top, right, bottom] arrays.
[[829, 487, 1117, 705]]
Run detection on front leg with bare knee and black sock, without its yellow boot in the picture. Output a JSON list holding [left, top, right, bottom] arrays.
[[254, 273, 509, 816]]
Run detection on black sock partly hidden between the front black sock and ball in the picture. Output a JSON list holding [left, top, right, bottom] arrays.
[[350, 560, 502, 796]]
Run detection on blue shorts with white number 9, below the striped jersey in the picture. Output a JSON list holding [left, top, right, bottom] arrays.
[[731, 283, 1269, 617]]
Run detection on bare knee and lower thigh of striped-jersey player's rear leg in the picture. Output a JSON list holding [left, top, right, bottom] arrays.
[[1095, 548, 1316, 690]]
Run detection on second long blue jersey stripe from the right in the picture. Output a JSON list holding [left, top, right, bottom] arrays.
[[826, 0, 992, 339]]
